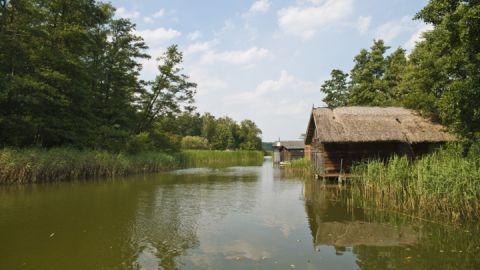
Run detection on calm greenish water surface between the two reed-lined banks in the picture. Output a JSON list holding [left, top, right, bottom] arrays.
[[0, 161, 480, 269]]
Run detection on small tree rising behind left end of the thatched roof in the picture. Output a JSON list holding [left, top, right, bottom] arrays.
[[320, 69, 350, 108]]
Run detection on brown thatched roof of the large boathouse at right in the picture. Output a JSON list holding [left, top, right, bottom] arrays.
[[305, 107, 455, 144]]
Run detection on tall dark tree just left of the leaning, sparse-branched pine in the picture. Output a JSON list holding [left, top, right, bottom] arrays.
[[89, 16, 149, 150]]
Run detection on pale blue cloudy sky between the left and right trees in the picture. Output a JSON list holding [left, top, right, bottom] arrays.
[[111, 0, 431, 141]]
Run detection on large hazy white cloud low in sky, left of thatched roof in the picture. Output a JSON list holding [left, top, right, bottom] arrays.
[[217, 71, 322, 140]]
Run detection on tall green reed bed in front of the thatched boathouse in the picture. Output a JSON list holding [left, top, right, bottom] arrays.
[[352, 144, 480, 221]]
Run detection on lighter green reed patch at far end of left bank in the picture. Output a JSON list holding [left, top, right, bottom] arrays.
[[178, 150, 263, 168]]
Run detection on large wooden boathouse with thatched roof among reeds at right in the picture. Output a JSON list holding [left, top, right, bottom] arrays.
[[305, 107, 455, 174]]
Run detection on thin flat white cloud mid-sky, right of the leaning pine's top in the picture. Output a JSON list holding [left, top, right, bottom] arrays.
[[202, 47, 270, 65]]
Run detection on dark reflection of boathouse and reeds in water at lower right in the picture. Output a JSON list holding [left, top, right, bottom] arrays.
[[304, 180, 480, 269]]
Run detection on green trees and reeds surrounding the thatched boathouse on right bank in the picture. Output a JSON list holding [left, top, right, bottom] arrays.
[[321, 0, 480, 220]]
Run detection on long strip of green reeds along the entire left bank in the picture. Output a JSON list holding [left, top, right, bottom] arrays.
[[0, 148, 263, 184]]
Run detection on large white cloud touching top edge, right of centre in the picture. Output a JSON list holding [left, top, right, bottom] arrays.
[[277, 0, 354, 39]]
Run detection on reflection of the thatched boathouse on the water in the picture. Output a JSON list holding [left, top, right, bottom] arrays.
[[305, 180, 418, 250]]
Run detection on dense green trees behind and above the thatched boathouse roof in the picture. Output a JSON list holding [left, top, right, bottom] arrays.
[[321, 0, 480, 142]]
